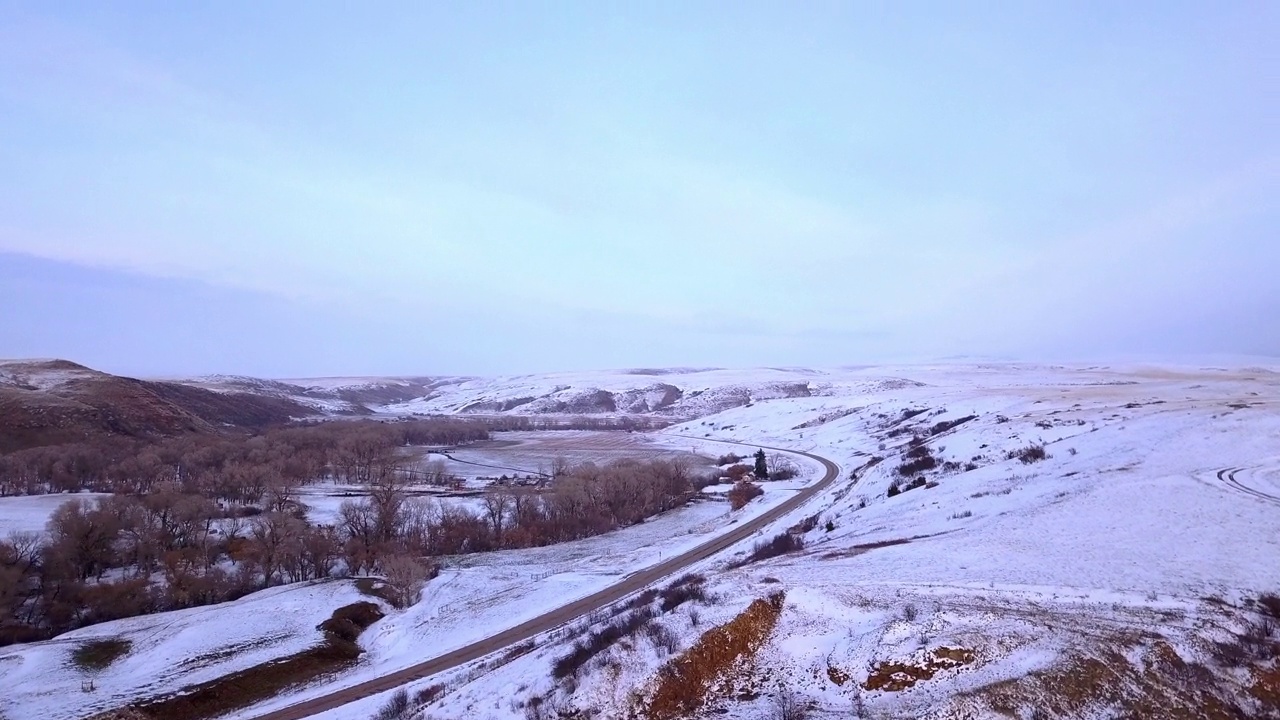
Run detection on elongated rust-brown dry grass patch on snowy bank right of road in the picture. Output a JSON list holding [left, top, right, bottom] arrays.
[[645, 592, 786, 720]]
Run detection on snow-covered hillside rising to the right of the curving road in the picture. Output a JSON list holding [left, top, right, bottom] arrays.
[[325, 365, 1280, 720]]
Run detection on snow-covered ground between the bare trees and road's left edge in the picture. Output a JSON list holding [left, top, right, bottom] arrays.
[[0, 430, 820, 720]]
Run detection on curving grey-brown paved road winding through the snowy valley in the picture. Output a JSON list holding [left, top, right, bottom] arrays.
[[245, 441, 840, 720]]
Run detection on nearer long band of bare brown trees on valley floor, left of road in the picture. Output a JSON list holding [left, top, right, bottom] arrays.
[[0, 448, 695, 644]]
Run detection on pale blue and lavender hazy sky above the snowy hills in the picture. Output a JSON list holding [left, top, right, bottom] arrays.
[[0, 0, 1280, 377]]
